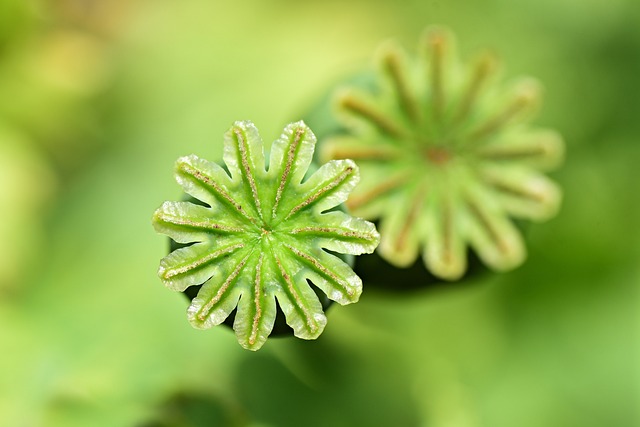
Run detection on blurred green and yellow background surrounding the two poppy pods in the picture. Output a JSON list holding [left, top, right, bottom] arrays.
[[0, 0, 640, 427]]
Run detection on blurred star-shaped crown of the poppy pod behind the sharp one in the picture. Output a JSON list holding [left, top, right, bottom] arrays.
[[320, 29, 564, 280]]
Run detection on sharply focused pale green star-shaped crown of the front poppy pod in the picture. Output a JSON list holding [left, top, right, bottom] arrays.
[[153, 122, 379, 350]]
